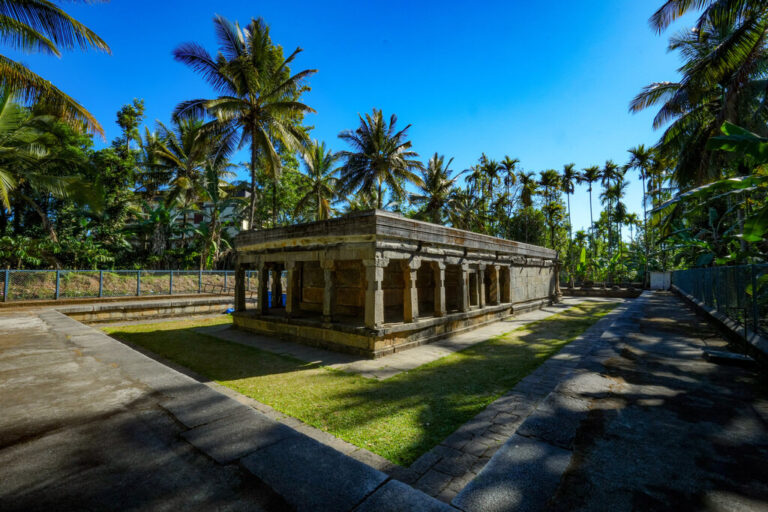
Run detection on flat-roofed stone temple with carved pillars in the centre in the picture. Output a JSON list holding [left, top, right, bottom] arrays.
[[234, 210, 559, 357]]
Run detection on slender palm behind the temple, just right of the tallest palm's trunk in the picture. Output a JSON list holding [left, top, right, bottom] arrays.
[[296, 140, 339, 220]]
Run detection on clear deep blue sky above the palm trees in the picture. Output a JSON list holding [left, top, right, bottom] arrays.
[[22, 0, 689, 235]]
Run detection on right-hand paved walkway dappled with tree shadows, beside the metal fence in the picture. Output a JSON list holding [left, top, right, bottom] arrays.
[[452, 292, 768, 512]]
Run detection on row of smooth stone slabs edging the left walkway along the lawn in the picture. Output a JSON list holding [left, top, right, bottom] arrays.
[[39, 309, 455, 511]]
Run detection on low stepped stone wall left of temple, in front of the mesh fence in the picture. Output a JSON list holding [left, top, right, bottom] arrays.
[[55, 296, 234, 324]]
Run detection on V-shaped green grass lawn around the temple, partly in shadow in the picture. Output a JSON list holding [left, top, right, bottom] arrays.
[[105, 303, 616, 466]]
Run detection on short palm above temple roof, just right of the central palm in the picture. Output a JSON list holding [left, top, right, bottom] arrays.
[[411, 153, 461, 224]]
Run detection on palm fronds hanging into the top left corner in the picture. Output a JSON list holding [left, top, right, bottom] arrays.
[[0, 0, 110, 136]]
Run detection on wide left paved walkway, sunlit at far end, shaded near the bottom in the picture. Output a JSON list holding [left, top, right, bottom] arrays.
[[0, 310, 449, 512]]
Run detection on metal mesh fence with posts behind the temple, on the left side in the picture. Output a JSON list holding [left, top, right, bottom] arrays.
[[0, 270, 257, 302]]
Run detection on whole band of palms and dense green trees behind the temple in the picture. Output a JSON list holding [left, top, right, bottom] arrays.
[[0, 0, 768, 282]]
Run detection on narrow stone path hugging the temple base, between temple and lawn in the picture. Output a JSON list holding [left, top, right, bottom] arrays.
[[197, 297, 622, 380]]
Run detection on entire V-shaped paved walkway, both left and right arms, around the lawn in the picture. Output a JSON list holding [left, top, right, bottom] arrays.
[[0, 293, 768, 512]]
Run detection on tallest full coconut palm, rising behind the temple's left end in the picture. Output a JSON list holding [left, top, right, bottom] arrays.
[[173, 16, 317, 228]]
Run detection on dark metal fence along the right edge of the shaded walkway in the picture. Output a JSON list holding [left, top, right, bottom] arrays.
[[672, 265, 768, 335]]
